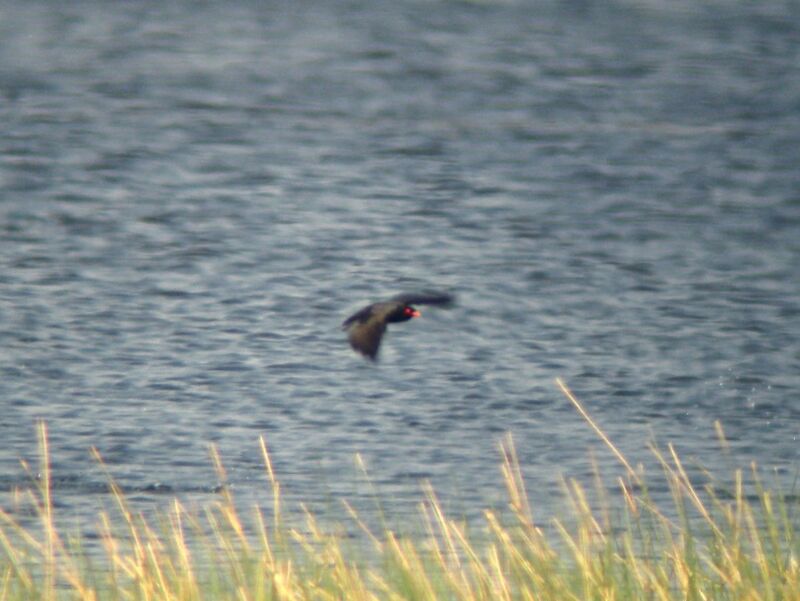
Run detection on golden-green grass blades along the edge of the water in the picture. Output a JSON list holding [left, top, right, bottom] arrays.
[[0, 381, 800, 601]]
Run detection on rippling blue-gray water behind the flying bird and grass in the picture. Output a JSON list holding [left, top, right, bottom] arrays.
[[0, 0, 800, 532]]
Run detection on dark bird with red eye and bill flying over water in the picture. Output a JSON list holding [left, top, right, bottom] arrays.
[[342, 292, 453, 361]]
